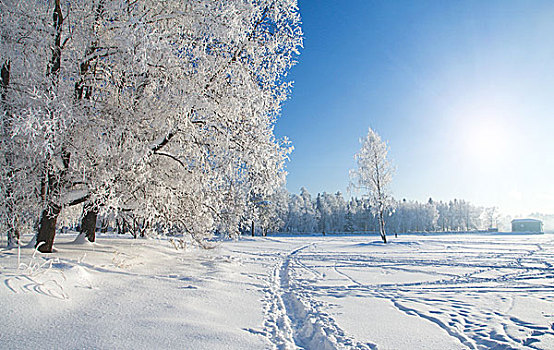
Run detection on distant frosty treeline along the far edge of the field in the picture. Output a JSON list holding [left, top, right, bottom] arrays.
[[261, 188, 499, 233]]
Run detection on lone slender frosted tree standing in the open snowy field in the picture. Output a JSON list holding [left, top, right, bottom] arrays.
[[350, 128, 394, 243]]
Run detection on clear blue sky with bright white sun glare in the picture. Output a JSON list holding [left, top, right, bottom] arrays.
[[275, 0, 554, 215]]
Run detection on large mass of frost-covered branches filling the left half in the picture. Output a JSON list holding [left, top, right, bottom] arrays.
[[0, 0, 302, 251]]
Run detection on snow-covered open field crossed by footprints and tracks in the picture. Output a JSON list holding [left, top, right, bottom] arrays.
[[0, 234, 554, 349]]
